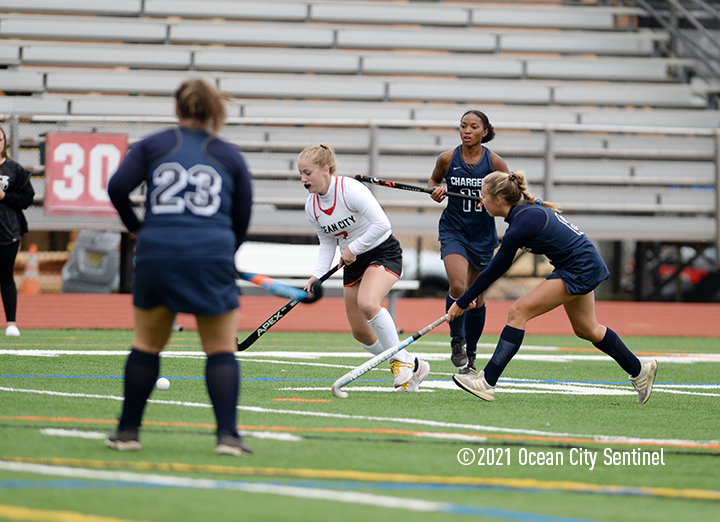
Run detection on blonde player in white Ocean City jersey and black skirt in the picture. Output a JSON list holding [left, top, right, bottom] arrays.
[[298, 143, 430, 391]]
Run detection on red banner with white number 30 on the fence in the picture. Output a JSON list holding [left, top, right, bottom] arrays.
[[45, 132, 127, 217]]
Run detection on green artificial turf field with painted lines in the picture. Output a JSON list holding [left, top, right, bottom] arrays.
[[0, 330, 720, 522]]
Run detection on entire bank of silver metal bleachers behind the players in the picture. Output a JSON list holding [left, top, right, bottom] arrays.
[[0, 0, 720, 253]]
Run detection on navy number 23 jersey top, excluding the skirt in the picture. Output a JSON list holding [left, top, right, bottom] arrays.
[[108, 128, 252, 261]]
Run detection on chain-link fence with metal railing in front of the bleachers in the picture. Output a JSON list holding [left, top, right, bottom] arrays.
[[4, 115, 720, 250]]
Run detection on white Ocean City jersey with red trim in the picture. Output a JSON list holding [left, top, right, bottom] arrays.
[[305, 176, 392, 278]]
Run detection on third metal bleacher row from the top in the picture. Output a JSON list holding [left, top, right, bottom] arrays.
[[0, 40, 692, 82]]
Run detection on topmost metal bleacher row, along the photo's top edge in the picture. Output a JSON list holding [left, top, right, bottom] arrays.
[[0, 0, 641, 29]]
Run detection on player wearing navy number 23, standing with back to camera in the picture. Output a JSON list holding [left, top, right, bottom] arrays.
[[106, 80, 252, 455]]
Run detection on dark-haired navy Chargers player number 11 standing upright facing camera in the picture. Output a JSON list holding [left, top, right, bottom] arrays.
[[428, 110, 508, 373]]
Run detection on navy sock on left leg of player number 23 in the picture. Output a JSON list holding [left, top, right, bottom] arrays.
[[118, 348, 160, 430]]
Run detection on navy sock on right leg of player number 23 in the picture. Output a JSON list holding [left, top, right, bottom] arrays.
[[205, 352, 240, 437]]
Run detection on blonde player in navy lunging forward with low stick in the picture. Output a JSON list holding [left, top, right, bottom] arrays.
[[448, 172, 657, 404]]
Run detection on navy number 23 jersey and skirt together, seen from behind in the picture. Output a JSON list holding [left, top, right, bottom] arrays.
[[108, 127, 252, 315]]
